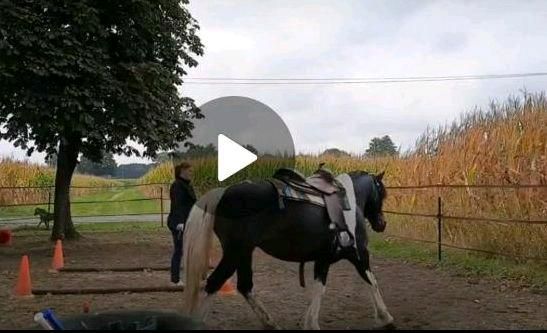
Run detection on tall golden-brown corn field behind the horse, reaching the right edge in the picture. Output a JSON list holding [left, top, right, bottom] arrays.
[[141, 93, 547, 257]]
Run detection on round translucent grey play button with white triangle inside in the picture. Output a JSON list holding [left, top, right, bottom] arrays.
[[172, 96, 297, 208]]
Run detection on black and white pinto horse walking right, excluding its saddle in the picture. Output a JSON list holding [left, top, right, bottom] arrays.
[[184, 171, 394, 329]]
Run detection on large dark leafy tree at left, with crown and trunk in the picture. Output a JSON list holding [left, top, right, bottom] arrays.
[[0, 0, 203, 239]]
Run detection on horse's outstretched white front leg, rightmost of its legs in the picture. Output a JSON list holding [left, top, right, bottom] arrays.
[[350, 249, 395, 329]]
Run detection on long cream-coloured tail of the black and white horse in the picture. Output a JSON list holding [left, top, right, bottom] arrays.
[[183, 188, 224, 314]]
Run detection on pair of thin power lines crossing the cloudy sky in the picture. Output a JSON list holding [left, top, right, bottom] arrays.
[[184, 72, 547, 85]]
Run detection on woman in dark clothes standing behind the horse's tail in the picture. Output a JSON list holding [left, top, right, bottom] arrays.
[[167, 162, 196, 285]]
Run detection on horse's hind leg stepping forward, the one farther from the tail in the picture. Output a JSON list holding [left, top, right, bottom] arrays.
[[237, 248, 281, 329]]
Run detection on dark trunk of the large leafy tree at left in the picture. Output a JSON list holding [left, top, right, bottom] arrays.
[[51, 138, 80, 240]]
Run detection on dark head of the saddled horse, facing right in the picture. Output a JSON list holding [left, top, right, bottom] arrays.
[[350, 171, 387, 232]]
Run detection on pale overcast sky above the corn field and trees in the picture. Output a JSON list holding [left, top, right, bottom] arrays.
[[0, 0, 547, 163]]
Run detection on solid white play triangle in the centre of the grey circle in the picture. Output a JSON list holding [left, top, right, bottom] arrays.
[[217, 134, 258, 182]]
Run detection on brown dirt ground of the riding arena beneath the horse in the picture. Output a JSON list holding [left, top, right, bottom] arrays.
[[0, 231, 547, 329]]
